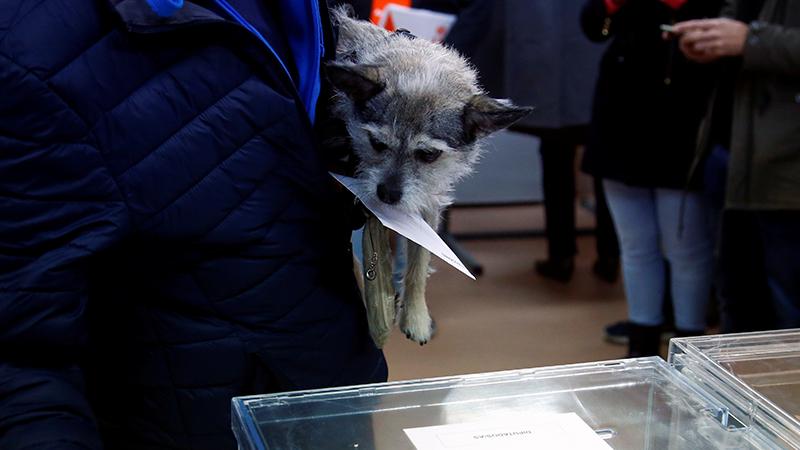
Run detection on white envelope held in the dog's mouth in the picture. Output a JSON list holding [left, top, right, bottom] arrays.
[[331, 173, 475, 280]]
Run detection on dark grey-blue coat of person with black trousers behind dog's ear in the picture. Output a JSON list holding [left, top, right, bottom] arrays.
[[504, 0, 603, 129]]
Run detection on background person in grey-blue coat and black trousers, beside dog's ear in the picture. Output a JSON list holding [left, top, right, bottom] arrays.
[[505, 0, 619, 282]]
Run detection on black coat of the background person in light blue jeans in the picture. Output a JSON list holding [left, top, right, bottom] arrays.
[[581, 0, 722, 189]]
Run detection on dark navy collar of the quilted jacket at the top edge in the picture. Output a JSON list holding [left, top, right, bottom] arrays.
[[108, 0, 225, 33]]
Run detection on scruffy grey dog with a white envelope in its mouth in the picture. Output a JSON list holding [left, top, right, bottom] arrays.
[[326, 8, 530, 344]]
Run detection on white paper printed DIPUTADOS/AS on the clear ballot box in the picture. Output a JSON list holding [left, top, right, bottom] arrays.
[[403, 413, 611, 450]]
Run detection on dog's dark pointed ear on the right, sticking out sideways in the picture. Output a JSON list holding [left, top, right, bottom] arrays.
[[463, 95, 533, 143]]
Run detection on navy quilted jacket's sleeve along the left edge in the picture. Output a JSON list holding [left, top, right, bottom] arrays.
[[0, 54, 129, 450]]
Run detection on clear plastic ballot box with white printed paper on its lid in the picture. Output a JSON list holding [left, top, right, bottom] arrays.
[[232, 358, 777, 450]]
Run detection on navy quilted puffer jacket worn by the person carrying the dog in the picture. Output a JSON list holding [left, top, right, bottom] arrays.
[[0, 0, 386, 450]]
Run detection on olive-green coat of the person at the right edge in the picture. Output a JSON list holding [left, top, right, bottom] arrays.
[[724, 0, 800, 210]]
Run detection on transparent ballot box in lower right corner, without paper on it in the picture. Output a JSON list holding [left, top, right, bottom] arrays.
[[669, 330, 800, 449]]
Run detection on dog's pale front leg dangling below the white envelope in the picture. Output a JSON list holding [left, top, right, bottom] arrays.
[[400, 209, 439, 345]]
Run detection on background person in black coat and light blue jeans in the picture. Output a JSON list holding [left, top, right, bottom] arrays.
[[582, 0, 721, 357]]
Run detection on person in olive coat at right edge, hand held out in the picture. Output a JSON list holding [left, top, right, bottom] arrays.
[[675, 0, 800, 332]]
